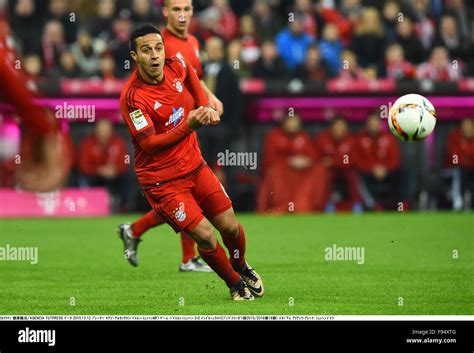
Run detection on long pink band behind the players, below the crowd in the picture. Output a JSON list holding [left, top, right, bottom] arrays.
[[0, 95, 474, 124]]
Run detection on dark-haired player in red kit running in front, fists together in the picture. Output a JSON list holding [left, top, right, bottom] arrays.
[[120, 25, 264, 300]]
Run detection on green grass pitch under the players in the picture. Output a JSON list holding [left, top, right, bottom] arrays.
[[0, 213, 474, 315]]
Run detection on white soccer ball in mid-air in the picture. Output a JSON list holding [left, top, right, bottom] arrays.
[[388, 94, 436, 141]]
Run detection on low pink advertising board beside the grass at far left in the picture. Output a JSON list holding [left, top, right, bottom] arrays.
[[0, 188, 110, 218]]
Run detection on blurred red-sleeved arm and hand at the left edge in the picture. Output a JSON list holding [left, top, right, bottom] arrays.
[[0, 13, 72, 192]]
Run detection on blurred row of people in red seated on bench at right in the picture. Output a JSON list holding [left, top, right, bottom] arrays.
[[257, 112, 474, 212]]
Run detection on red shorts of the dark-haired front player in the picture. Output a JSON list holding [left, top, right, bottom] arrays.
[[144, 164, 232, 232]]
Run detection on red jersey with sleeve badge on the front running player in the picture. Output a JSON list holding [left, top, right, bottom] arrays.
[[120, 57, 209, 189]]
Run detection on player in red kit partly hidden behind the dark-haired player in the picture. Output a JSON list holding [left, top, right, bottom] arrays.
[[119, 0, 223, 272]]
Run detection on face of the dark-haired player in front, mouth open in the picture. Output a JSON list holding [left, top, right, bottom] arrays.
[[130, 33, 165, 83]]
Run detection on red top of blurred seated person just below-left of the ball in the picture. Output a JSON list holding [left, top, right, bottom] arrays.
[[357, 130, 400, 172]]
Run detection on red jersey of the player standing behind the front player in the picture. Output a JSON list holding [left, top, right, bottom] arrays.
[[161, 28, 203, 79]]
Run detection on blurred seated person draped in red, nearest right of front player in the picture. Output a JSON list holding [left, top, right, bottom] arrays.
[[257, 114, 327, 213]]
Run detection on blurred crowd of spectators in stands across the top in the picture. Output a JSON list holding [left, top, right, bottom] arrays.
[[8, 0, 474, 81]]
